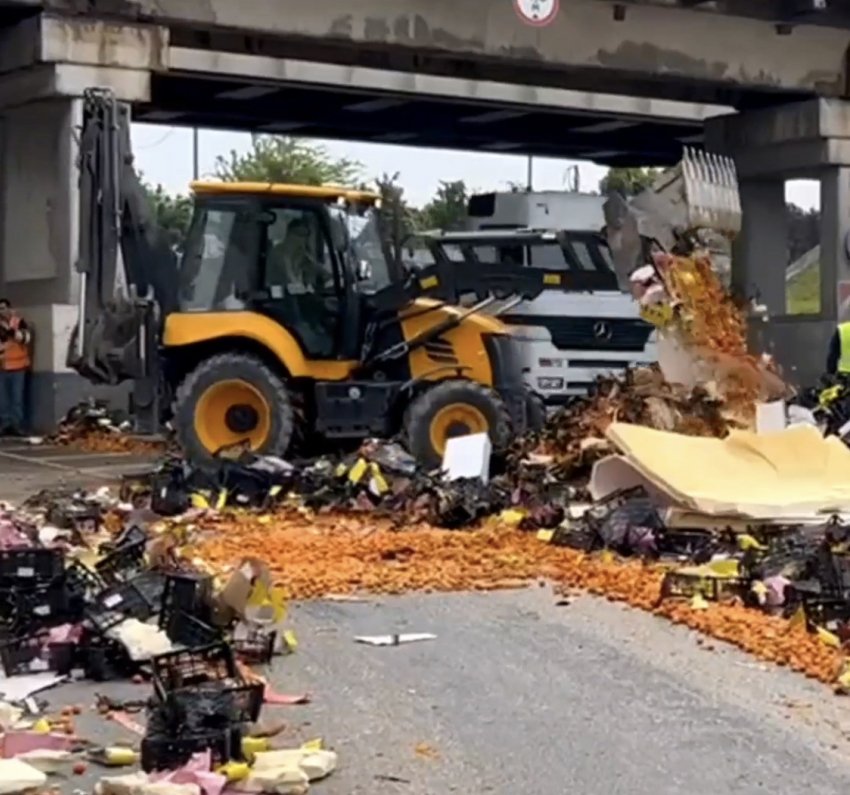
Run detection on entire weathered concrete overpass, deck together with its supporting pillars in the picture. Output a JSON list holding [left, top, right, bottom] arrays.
[[0, 0, 850, 423]]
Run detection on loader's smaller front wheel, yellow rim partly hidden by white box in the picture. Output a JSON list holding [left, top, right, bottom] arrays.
[[404, 379, 511, 469]]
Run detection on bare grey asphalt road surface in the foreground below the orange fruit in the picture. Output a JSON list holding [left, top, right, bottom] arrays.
[[33, 587, 850, 795]]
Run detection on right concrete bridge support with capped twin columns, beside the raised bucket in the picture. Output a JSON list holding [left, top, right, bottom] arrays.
[[706, 99, 850, 385]]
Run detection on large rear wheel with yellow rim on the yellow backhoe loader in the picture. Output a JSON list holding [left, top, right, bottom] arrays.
[[174, 353, 293, 463]]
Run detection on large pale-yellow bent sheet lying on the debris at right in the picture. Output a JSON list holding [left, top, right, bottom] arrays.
[[599, 423, 850, 519]]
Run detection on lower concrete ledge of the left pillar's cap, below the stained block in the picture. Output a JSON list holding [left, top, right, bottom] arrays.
[[0, 64, 150, 110]]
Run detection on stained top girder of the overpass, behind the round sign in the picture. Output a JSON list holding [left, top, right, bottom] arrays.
[[4, 0, 850, 107]]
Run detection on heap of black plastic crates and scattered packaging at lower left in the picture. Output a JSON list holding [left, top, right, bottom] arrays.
[[0, 498, 336, 792]]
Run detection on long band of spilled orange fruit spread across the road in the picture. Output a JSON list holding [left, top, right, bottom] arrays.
[[193, 514, 843, 683]]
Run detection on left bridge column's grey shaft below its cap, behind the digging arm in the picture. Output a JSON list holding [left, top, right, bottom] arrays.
[[0, 98, 131, 432]]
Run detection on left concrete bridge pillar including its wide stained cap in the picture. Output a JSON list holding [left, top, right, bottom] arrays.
[[0, 16, 168, 432]]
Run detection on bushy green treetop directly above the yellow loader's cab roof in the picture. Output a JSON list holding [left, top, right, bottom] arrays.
[[215, 135, 363, 186]]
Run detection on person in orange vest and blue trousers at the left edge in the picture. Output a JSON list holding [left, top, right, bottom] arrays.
[[0, 298, 32, 436]]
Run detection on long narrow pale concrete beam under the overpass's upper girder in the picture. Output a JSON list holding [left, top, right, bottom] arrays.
[[169, 47, 732, 122]]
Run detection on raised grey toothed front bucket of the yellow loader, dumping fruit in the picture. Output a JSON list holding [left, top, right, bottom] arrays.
[[604, 148, 741, 286]]
